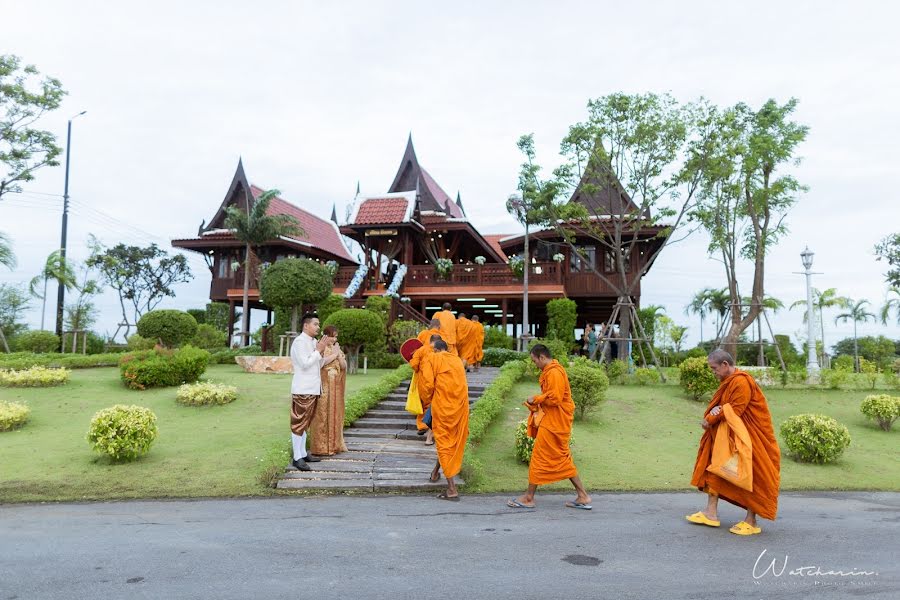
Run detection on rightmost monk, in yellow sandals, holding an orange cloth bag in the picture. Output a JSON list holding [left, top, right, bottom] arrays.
[[686, 350, 781, 535]]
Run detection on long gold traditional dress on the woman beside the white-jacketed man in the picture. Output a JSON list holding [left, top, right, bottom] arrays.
[[310, 346, 347, 456]]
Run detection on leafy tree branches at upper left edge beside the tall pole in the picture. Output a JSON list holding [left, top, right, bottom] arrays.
[[0, 54, 66, 200]]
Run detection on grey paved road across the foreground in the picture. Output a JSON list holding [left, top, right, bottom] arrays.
[[0, 493, 900, 600]]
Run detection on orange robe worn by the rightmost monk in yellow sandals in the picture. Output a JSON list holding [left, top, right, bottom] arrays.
[[691, 370, 781, 521]]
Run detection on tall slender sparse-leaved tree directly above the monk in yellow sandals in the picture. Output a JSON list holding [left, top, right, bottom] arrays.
[[692, 99, 809, 355]]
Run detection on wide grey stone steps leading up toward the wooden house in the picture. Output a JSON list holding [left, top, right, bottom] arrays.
[[276, 367, 500, 492]]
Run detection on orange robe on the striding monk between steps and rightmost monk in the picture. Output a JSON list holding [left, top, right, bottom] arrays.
[[528, 359, 578, 485]]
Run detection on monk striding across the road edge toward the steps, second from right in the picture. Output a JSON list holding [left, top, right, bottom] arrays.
[[506, 344, 593, 510]]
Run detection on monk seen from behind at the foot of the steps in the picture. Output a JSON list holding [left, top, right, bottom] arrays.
[[417, 340, 469, 502]]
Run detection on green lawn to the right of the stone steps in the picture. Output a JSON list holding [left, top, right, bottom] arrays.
[[470, 379, 900, 492]]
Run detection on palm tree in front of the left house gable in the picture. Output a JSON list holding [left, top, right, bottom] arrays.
[[225, 190, 304, 346]]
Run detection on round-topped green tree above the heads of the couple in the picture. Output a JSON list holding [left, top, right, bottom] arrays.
[[259, 258, 331, 331]]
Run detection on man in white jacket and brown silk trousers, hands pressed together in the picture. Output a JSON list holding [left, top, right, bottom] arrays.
[[291, 313, 338, 471]]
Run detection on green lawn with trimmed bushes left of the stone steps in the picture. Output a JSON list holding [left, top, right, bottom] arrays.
[[0, 365, 388, 502]]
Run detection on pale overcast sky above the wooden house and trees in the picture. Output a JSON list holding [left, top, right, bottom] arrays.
[[0, 0, 900, 346]]
